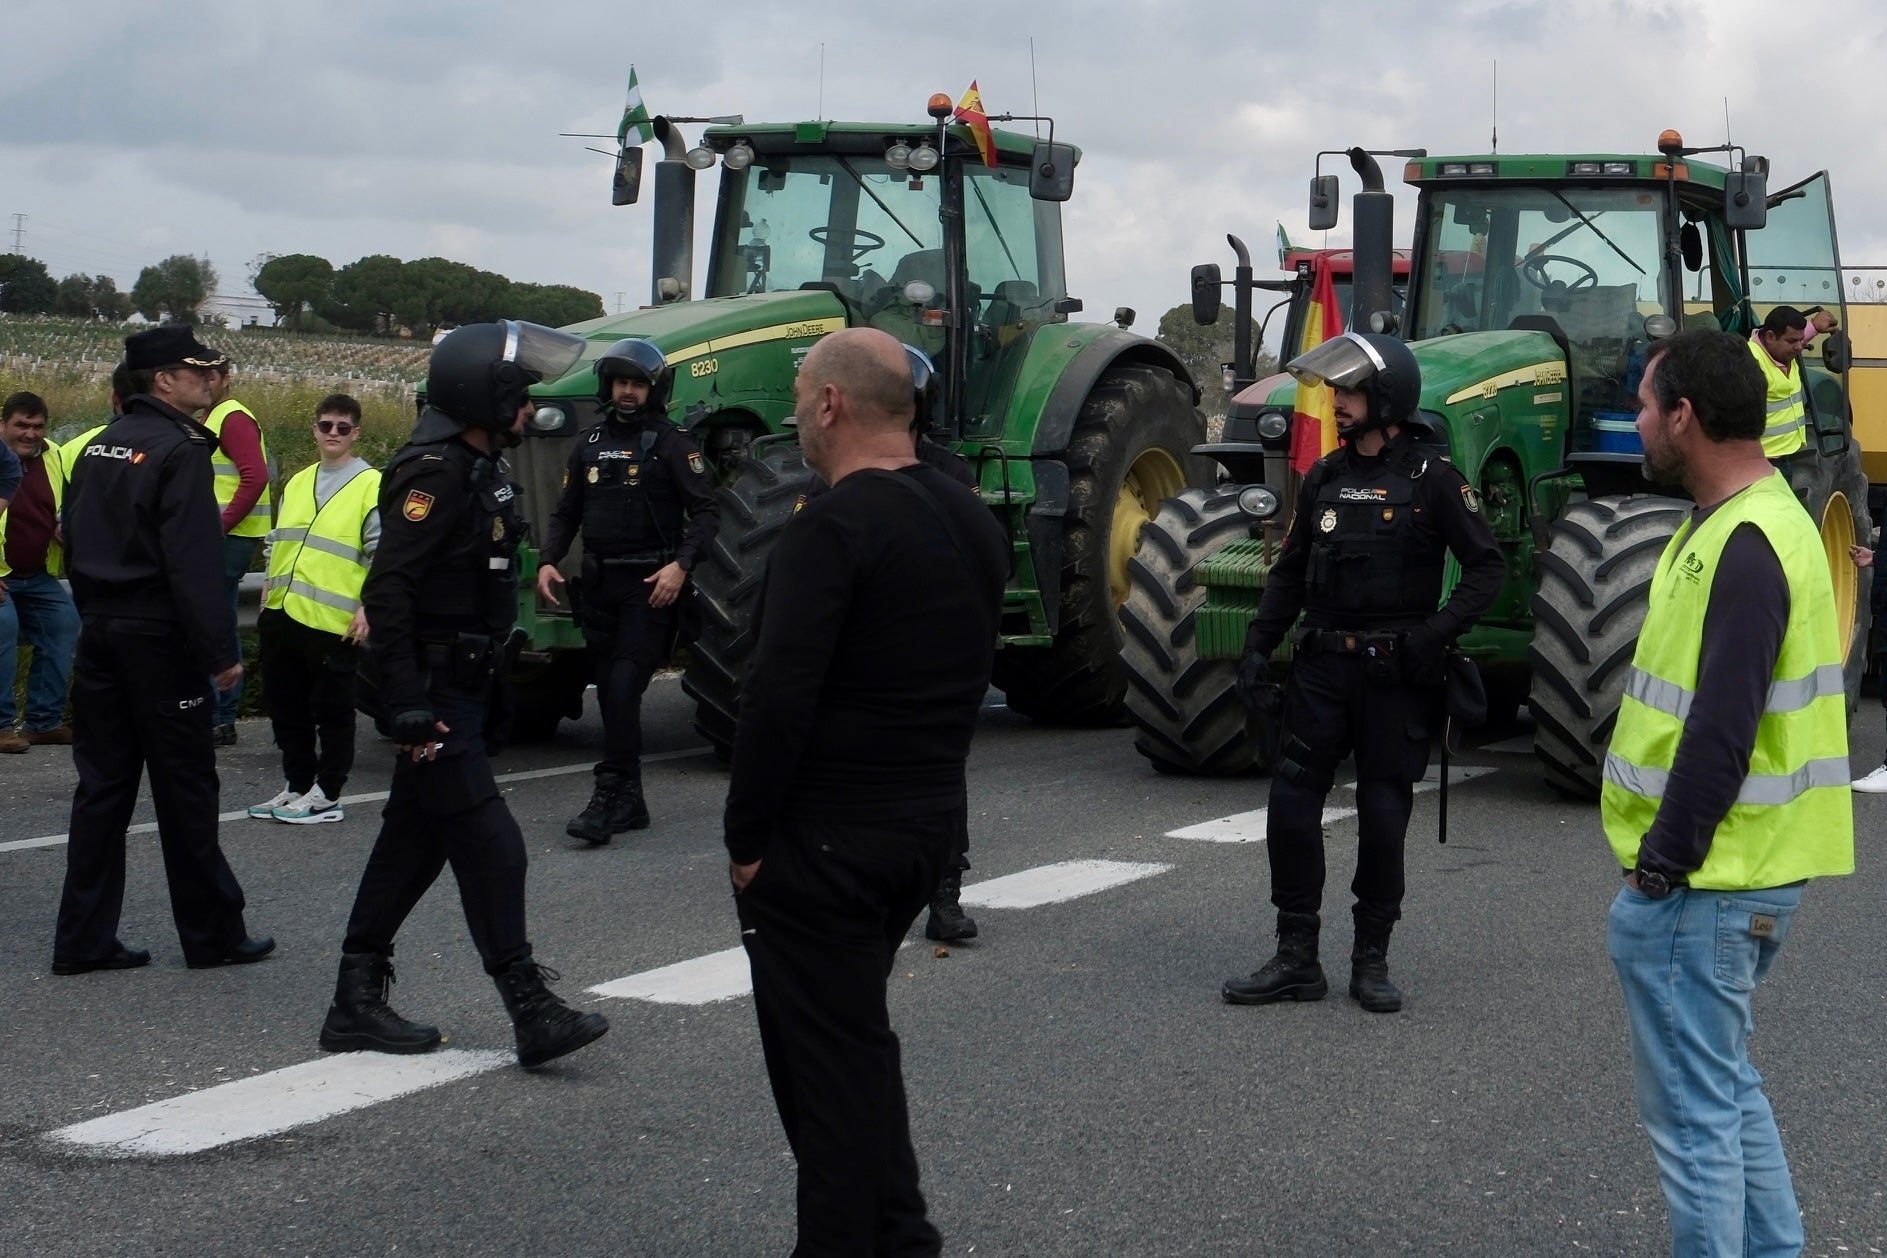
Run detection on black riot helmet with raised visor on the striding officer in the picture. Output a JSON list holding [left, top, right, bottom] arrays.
[[426, 319, 583, 434]]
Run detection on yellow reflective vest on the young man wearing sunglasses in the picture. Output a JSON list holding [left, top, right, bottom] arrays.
[[262, 464, 379, 634]]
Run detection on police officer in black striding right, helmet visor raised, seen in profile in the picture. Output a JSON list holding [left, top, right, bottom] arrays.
[[321, 321, 610, 1068]]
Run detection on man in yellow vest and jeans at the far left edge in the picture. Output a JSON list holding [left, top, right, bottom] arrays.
[[0, 392, 79, 753]]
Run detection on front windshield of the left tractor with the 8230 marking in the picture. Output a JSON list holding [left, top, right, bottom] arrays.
[[708, 155, 944, 319]]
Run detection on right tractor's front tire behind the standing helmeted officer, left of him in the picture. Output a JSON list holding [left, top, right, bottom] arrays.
[[1121, 488, 1270, 777]]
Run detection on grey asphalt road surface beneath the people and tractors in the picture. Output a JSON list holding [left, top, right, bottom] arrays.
[[0, 679, 1887, 1256]]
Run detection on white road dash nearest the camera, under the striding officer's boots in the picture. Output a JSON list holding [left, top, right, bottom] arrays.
[[49, 1049, 517, 1156]]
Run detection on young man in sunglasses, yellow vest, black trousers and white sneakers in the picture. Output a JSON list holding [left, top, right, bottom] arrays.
[[249, 392, 379, 826]]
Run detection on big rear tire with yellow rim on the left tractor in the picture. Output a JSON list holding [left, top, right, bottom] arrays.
[[994, 364, 1213, 724]]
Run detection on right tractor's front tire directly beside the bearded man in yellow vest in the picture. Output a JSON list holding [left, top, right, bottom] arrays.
[[1528, 494, 1691, 800]]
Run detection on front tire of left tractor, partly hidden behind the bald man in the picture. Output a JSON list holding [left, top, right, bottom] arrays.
[[681, 441, 813, 760]]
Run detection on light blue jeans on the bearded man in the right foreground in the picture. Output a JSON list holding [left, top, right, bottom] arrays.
[[1606, 885, 1802, 1258]]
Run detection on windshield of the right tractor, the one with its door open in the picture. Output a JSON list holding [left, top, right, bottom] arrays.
[[1411, 185, 1670, 411]]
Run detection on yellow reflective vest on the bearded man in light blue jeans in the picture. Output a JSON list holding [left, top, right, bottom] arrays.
[[1600, 473, 1855, 890]]
